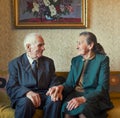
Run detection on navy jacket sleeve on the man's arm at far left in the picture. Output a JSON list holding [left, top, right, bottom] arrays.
[[6, 61, 30, 101]]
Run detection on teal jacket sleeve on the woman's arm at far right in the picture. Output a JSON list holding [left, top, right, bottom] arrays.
[[84, 56, 110, 100]]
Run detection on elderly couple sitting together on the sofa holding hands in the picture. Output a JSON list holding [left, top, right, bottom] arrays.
[[6, 32, 113, 118]]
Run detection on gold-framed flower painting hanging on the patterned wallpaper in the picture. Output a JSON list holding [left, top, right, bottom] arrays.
[[13, 0, 87, 28]]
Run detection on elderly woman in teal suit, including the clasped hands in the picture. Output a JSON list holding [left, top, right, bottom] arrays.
[[47, 32, 113, 118]]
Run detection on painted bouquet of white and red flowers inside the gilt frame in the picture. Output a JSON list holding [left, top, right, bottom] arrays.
[[26, 0, 73, 20]]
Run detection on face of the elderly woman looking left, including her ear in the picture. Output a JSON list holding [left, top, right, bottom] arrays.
[[77, 35, 92, 56]]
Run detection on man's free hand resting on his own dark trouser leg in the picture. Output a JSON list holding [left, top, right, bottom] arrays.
[[26, 91, 41, 108]]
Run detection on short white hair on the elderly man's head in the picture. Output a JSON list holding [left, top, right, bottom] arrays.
[[24, 33, 41, 50]]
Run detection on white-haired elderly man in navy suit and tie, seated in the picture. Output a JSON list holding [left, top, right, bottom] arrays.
[[6, 33, 61, 118]]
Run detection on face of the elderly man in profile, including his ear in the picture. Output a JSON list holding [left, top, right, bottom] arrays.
[[28, 36, 45, 59]]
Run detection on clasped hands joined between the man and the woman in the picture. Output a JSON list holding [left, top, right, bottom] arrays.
[[46, 85, 64, 102]]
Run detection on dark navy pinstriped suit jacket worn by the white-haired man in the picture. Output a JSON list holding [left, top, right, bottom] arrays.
[[6, 54, 55, 106]]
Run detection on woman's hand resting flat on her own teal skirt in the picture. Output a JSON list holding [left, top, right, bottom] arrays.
[[67, 96, 86, 111]]
